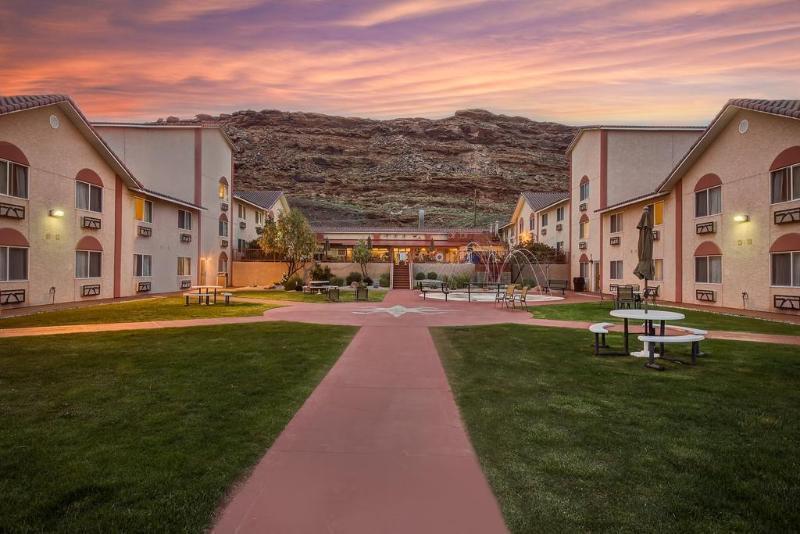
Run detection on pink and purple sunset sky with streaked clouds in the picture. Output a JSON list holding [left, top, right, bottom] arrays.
[[0, 0, 800, 124]]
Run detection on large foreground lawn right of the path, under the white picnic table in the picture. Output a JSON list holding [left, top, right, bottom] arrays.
[[434, 325, 800, 533]]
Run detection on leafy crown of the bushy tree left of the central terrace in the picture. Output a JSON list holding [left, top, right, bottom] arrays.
[[258, 210, 317, 282]]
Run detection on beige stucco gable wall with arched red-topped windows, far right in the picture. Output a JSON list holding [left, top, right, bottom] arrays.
[[682, 110, 800, 311]]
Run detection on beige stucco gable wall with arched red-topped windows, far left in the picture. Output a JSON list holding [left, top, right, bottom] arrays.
[[0, 105, 116, 308]]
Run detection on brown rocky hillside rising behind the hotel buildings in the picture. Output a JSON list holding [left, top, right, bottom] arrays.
[[167, 110, 575, 226]]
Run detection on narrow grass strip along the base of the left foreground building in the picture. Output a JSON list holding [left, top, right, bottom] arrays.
[[0, 297, 275, 328]]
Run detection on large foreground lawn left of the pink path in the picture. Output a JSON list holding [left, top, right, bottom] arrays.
[[0, 323, 355, 532]]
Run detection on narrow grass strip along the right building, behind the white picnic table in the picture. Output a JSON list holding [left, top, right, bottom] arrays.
[[528, 301, 800, 336]]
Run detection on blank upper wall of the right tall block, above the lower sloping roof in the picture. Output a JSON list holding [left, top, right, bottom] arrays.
[[606, 130, 702, 206]]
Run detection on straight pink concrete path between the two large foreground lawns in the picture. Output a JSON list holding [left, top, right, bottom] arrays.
[[214, 319, 506, 534]]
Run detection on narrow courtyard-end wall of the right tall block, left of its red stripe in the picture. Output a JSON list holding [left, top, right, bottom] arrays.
[[567, 130, 600, 290]]
